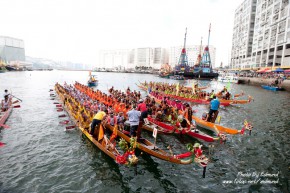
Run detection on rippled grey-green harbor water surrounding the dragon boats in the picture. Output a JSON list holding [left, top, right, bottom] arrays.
[[0, 70, 290, 193]]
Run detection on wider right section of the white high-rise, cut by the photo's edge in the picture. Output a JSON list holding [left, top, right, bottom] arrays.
[[251, 0, 290, 67]]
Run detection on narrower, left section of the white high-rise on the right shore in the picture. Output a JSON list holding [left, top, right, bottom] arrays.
[[231, 0, 257, 68]]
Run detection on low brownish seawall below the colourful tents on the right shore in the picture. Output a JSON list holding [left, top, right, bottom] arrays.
[[238, 77, 290, 92]]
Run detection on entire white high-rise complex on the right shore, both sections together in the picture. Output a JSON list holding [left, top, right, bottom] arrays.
[[231, 0, 290, 69]]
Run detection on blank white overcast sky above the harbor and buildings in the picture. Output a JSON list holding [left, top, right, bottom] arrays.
[[0, 0, 242, 66]]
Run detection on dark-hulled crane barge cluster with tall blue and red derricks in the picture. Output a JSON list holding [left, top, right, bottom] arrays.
[[173, 27, 218, 79]]
